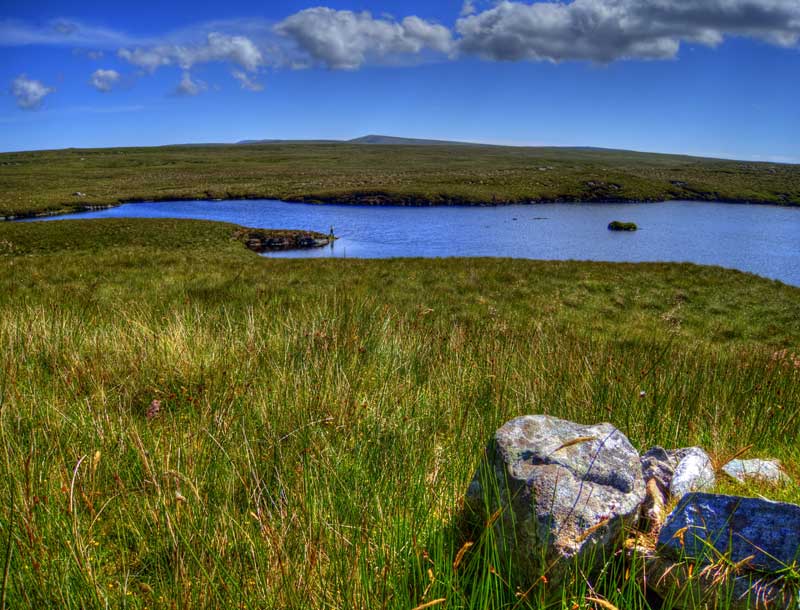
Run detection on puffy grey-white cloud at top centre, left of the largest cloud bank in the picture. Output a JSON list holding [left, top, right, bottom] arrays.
[[275, 7, 453, 70]]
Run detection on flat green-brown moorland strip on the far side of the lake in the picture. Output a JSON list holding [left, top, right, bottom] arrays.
[[0, 143, 800, 216]]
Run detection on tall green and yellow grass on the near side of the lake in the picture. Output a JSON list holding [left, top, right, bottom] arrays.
[[0, 220, 800, 609]]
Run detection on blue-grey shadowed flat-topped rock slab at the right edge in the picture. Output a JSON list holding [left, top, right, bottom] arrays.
[[657, 493, 800, 573]]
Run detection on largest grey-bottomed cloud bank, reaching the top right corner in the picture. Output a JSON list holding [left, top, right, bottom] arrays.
[[456, 0, 800, 63]]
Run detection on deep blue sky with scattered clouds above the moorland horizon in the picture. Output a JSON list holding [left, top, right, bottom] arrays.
[[0, 0, 800, 163]]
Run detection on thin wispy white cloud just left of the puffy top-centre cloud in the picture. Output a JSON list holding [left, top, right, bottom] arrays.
[[118, 32, 264, 72]]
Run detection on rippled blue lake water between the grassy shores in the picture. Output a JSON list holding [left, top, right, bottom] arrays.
[[26, 200, 800, 286]]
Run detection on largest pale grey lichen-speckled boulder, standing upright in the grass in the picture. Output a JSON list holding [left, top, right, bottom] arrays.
[[467, 415, 645, 584]]
